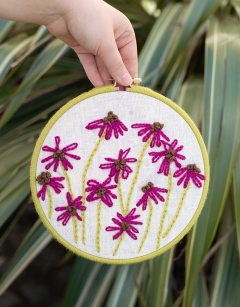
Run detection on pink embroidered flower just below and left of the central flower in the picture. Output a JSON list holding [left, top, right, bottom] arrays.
[[86, 177, 117, 207]]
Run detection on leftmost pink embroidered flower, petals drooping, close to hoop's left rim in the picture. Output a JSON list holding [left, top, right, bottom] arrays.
[[36, 172, 65, 200]]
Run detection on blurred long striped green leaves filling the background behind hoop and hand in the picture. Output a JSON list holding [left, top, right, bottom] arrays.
[[0, 0, 240, 307]]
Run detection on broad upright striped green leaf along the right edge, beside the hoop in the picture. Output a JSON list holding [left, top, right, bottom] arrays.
[[183, 18, 240, 307]]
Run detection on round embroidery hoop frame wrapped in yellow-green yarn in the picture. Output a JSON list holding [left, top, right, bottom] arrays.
[[30, 85, 209, 264]]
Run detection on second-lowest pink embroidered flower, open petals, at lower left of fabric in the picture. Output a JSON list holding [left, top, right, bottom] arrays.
[[55, 192, 87, 226]]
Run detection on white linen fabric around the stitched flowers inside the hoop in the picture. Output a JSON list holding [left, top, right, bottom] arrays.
[[36, 92, 204, 259]]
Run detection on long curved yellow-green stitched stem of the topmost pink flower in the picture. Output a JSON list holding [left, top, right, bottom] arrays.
[[82, 132, 106, 244]]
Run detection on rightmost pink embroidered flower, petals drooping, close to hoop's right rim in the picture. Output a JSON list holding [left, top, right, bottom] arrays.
[[173, 164, 205, 188]]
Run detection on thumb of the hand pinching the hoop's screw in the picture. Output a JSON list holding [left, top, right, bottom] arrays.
[[100, 40, 132, 86]]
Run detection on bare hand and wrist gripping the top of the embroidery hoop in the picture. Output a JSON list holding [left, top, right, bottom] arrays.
[[0, 0, 138, 86]]
